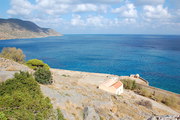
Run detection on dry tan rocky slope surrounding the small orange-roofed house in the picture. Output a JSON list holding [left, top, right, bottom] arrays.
[[41, 69, 178, 120]]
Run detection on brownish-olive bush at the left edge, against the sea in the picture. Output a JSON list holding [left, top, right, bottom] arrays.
[[0, 47, 25, 63]]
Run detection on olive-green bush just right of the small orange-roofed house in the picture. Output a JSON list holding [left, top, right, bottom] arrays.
[[121, 79, 137, 90]]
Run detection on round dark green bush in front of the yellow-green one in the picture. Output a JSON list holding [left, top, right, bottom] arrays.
[[34, 68, 52, 84]]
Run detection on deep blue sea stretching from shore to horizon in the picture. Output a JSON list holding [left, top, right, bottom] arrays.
[[0, 34, 180, 94]]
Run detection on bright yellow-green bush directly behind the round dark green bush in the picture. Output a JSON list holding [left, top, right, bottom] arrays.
[[26, 59, 50, 70]]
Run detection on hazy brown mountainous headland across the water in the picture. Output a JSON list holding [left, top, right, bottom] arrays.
[[0, 19, 61, 39]]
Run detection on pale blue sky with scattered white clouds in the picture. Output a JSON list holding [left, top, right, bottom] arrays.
[[0, 0, 180, 35]]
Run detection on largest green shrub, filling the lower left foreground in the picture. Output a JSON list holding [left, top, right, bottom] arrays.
[[0, 72, 53, 120]]
